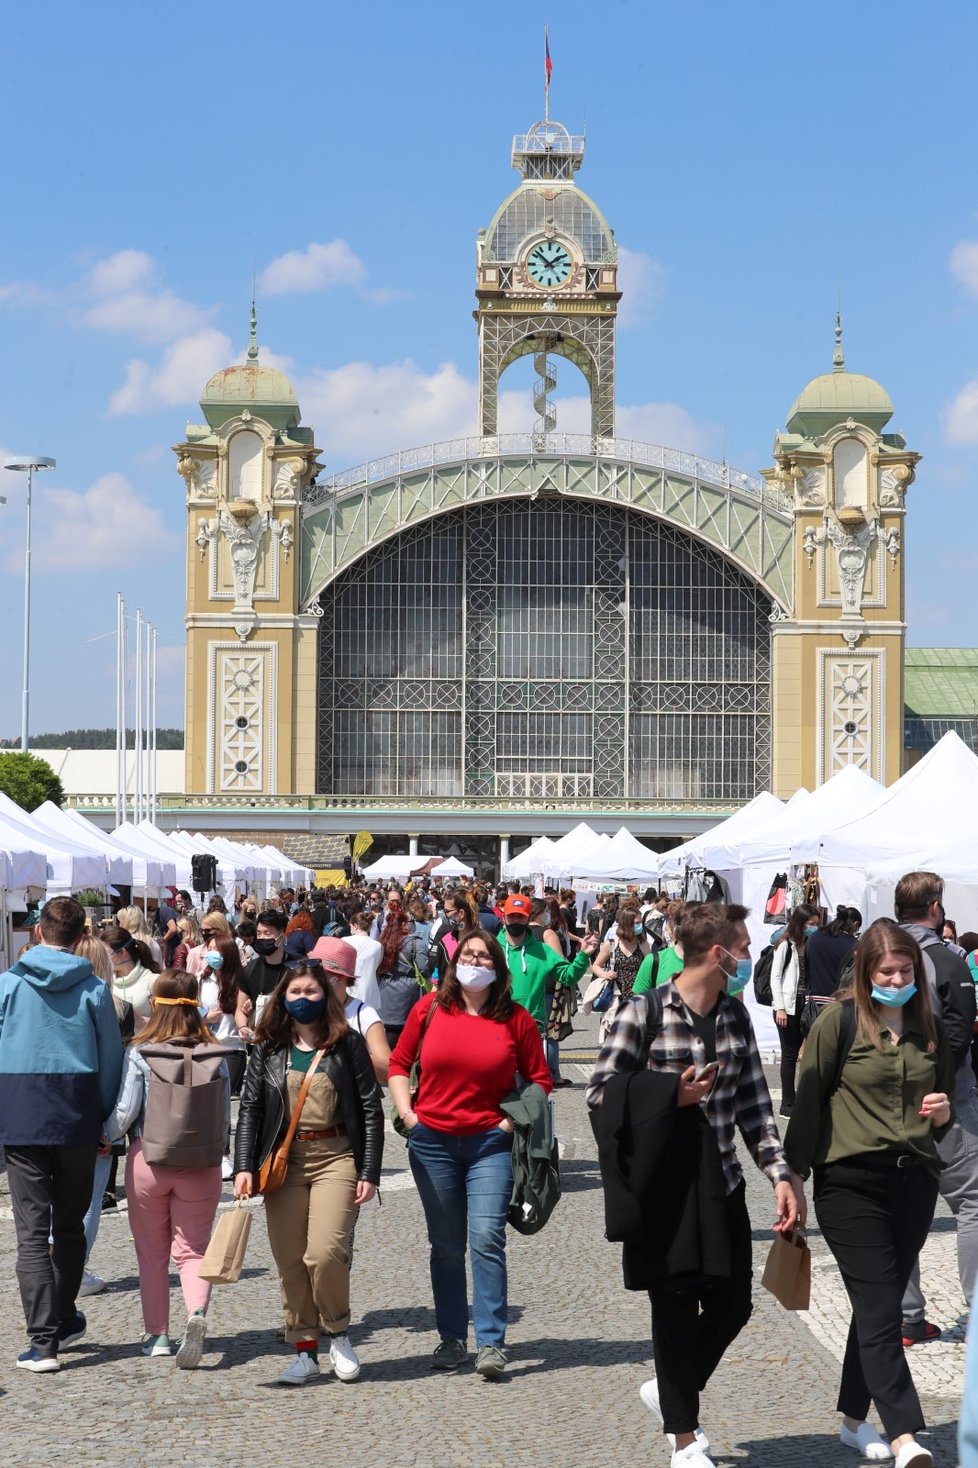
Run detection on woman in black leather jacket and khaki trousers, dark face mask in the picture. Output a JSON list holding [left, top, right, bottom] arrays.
[[235, 964, 383, 1386]]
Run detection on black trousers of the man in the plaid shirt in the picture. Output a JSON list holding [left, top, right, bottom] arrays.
[[649, 1182, 752, 1433]]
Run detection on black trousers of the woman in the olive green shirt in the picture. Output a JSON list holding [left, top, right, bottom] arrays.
[[815, 1157, 937, 1437]]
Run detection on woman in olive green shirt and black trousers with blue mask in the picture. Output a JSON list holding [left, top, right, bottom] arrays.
[[784, 919, 955, 1468]]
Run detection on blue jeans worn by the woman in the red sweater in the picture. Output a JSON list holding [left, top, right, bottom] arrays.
[[408, 1122, 512, 1346]]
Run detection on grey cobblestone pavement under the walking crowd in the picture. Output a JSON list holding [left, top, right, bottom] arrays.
[[0, 1022, 963, 1468]]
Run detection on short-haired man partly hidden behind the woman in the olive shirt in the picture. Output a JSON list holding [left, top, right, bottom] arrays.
[[893, 872, 978, 1346]]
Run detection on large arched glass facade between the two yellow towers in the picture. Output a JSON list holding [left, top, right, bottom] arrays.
[[319, 499, 771, 802]]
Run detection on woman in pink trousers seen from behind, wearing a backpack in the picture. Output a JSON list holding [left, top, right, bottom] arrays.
[[109, 969, 231, 1370]]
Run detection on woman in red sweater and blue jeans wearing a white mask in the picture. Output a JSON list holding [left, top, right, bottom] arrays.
[[389, 928, 552, 1380]]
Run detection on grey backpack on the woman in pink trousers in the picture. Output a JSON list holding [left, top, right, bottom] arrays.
[[140, 1041, 228, 1167]]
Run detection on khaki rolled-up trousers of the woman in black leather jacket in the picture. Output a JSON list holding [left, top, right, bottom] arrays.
[[264, 1136, 357, 1345]]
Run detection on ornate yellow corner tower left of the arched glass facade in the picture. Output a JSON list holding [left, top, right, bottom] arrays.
[[175, 305, 319, 797]]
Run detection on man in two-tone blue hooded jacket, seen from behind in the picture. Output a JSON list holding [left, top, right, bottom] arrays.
[[0, 897, 122, 1371]]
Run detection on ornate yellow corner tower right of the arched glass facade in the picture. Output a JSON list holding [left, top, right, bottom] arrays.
[[765, 316, 919, 796]]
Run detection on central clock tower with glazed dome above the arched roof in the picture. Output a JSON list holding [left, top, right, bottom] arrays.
[[474, 120, 621, 437]]
